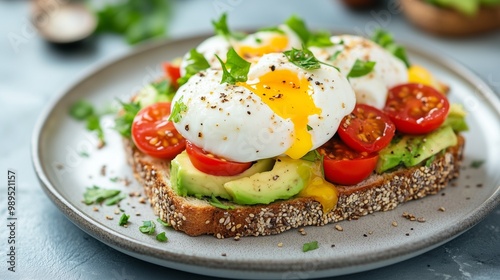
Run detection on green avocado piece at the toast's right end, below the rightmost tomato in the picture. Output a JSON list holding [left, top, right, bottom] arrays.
[[376, 125, 457, 173]]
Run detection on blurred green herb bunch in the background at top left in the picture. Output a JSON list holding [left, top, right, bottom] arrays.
[[95, 0, 170, 44]]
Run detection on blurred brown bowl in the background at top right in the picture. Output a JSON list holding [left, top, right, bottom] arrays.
[[400, 0, 500, 37]]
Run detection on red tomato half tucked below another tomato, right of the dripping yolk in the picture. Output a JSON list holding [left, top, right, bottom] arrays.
[[318, 137, 378, 185]]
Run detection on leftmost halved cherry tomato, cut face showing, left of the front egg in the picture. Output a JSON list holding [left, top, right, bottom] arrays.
[[132, 102, 186, 160]]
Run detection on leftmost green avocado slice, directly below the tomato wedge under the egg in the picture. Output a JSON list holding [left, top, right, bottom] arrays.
[[170, 151, 274, 199]]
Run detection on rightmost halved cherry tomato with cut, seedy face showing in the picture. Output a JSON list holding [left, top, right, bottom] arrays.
[[384, 83, 450, 134]]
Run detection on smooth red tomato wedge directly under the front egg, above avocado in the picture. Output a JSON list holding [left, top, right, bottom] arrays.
[[186, 141, 252, 176]]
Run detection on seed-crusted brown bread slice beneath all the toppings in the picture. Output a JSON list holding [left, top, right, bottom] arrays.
[[124, 136, 465, 238]]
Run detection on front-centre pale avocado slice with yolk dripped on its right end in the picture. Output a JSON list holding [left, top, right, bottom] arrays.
[[224, 157, 314, 205]]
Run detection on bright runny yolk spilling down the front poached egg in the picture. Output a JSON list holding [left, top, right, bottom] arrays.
[[239, 70, 321, 159]]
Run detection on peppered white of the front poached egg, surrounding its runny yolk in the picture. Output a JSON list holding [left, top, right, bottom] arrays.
[[172, 53, 356, 162]]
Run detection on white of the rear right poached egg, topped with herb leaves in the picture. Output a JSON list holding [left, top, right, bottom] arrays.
[[310, 35, 408, 109]]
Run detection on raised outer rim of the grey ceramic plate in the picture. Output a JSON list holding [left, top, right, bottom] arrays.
[[31, 33, 500, 275]]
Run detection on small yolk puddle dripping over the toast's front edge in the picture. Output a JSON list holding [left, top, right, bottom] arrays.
[[298, 164, 339, 213]]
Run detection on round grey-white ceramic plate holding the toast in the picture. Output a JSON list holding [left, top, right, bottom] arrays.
[[32, 34, 500, 279]]
